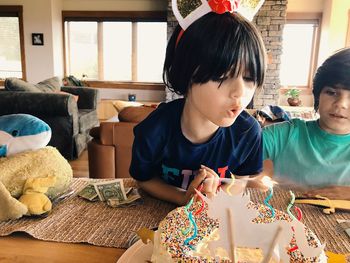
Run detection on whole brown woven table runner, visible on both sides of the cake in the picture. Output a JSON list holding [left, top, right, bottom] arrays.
[[0, 179, 350, 254]]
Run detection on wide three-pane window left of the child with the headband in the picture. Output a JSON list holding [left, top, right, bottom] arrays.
[[63, 11, 167, 88]]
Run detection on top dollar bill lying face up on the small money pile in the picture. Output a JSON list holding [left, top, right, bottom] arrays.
[[93, 179, 127, 202]]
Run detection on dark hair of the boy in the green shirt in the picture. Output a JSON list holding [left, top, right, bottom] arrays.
[[312, 48, 350, 111]]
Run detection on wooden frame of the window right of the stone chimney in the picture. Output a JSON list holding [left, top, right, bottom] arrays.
[[282, 12, 322, 92]]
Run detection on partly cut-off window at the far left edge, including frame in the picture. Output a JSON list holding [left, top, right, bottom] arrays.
[[0, 6, 26, 79]]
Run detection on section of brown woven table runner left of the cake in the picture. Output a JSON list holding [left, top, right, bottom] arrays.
[[0, 179, 174, 248]]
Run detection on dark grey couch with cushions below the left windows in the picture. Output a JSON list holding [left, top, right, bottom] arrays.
[[0, 77, 99, 160]]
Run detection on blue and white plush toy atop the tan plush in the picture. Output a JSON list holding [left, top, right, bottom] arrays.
[[0, 114, 51, 157]]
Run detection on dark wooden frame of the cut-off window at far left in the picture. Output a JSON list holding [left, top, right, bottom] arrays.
[[0, 5, 27, 86]]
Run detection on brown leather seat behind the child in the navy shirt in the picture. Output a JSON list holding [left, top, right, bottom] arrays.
[[88, 106, 155, 178]]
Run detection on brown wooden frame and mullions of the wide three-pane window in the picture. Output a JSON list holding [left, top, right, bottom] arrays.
[[62, 11, 167, 90]]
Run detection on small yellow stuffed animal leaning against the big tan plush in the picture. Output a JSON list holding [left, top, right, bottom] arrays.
[[18, 175, 56, 215]]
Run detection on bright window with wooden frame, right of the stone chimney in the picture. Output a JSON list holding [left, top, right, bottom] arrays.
[[280, 14, 321, 88]]
